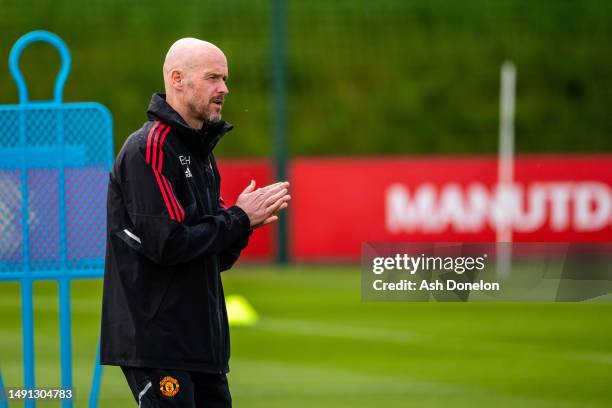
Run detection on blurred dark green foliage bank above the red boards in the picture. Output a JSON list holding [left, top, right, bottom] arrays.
[[0, 0, 612, 156]]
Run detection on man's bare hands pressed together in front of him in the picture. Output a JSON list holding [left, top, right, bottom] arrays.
[[236, 180, 291, 228]]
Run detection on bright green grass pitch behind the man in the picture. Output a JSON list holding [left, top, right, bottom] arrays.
[[0, 266, 612, 408]]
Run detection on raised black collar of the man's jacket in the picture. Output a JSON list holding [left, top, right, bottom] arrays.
[[147, 93, 234, 155]]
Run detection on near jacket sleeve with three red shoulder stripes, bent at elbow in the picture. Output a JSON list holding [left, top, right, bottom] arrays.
[[118, 135, 250, 264]]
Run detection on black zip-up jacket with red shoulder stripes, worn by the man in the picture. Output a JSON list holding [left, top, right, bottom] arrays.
[[100, 95, 250, 373]]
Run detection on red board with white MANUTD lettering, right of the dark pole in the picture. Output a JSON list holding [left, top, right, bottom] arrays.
[[289, 155, 612, 261]]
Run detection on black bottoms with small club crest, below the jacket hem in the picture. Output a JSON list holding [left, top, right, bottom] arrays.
[[121, 367, 232, 408]]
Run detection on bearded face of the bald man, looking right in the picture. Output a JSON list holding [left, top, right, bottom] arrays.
[[185, 56, 229, 122]]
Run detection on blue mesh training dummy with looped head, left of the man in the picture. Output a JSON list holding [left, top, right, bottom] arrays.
[[0, 31, 113, 407]]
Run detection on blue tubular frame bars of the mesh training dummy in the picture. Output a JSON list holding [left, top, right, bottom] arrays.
[[0, 31, 113, 408]]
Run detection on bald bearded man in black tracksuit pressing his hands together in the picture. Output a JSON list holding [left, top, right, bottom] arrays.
[[100, 38, 291, 407]]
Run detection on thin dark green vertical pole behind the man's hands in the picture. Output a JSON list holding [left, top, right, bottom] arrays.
[[271, 0, 289, 265]]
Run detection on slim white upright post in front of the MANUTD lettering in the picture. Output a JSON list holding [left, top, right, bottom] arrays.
[[496, 61, 516, 277]]
